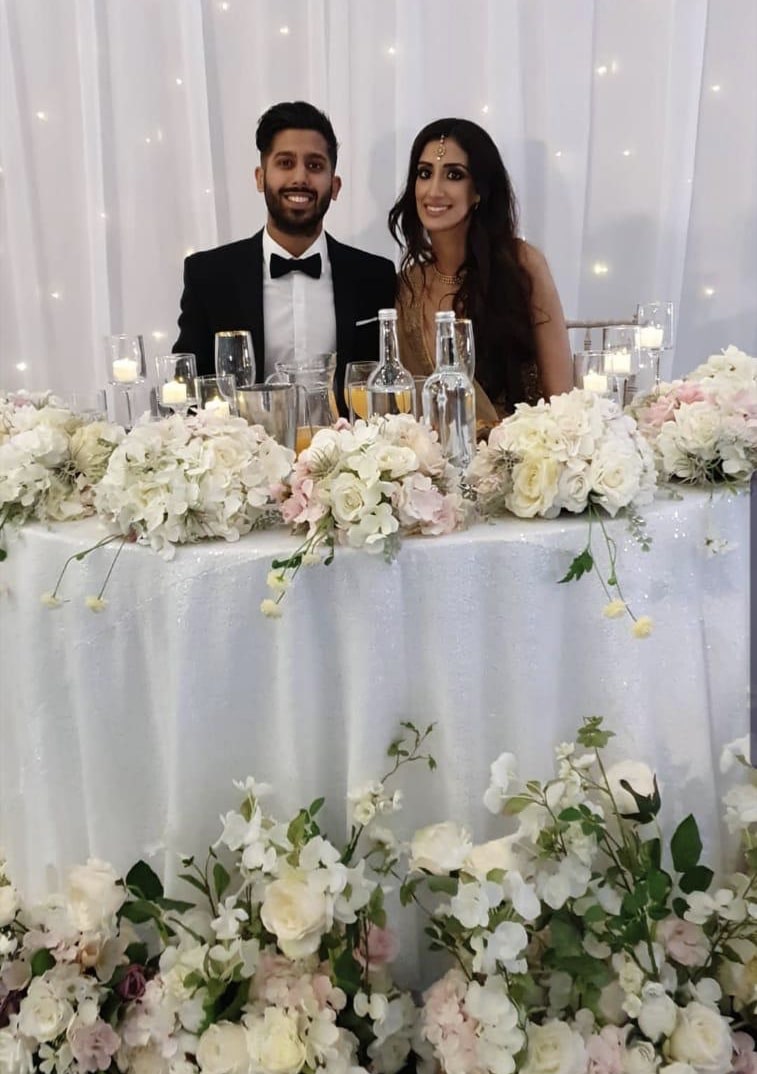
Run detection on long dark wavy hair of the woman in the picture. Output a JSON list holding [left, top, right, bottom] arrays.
[[389, 119, 536, 409]]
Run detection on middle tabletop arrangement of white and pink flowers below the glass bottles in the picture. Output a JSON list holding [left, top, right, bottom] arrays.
[[261, 415, 466, 616]]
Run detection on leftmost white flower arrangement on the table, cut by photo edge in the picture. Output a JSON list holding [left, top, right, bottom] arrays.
[[0, 392, 125, 560]]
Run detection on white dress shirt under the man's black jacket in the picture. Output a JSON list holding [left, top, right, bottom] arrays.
[[263, 228, 336, 377]]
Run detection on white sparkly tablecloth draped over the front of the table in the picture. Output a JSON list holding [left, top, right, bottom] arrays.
[[0, 492, 749, 983]]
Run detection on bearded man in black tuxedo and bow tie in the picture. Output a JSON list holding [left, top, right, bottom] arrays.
[[173, 101, 395, 410]]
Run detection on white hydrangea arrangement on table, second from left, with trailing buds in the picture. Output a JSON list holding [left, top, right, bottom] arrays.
[[43, 410, 294, 611]]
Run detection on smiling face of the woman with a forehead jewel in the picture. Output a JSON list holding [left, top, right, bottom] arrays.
[[416, 139, 479, 236]]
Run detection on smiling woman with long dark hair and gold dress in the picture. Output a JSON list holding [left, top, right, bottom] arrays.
[[389, 119, 572, 435]]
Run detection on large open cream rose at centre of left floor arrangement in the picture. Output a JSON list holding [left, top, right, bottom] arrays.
[[260, 874, 333, 958]]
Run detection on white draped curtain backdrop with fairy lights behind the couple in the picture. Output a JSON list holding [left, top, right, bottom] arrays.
[[0, 0, 757, 392]]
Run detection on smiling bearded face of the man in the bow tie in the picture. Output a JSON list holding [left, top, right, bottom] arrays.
[[254, 130, 341, 237]]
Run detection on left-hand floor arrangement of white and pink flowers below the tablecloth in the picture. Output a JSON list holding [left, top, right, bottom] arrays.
[[0, 724, 433, 1074]]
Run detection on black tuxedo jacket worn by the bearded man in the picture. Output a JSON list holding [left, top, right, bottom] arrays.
[[173, 230, 395, 409]]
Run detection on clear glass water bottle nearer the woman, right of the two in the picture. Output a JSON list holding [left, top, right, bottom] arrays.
[[423, 309, 476, 469]]
